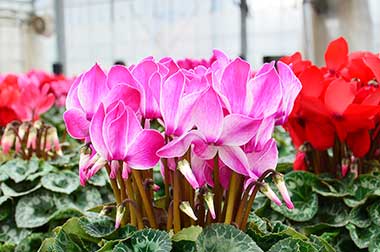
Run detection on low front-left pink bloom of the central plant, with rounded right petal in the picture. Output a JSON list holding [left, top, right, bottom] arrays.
[[80, 101, 164, 184]]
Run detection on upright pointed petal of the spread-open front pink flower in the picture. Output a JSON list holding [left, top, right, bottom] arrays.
[[194, 87, 223, 143]]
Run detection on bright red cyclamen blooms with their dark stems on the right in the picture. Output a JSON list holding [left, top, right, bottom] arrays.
[[281, 37, 380, 176]]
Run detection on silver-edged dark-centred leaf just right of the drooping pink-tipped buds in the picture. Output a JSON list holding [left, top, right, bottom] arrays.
[[271, 172, 318, 222]]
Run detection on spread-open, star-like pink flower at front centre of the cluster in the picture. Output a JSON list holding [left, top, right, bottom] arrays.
[[157, 87, 259, 178]]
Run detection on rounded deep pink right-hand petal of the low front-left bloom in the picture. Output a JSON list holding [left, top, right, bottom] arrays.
[[125, 129, 165, 169]]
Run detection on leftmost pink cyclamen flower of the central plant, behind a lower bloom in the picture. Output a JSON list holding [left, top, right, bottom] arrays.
[[63, 64, 140, 141]]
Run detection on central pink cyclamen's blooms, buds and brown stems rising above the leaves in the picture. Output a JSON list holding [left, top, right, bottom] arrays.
[[64, 50, 301, 232]]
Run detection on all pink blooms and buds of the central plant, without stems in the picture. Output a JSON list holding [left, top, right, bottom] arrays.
[[64, 50, 301, 228]]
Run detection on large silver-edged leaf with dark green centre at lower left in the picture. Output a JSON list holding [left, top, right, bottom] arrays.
[[15, 190, 57, 228]]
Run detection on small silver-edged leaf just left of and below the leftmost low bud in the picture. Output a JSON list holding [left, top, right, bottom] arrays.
[[79, 216, 115, 238]]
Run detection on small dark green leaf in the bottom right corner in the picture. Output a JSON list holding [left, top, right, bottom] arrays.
[[346, 224, 380, 248]]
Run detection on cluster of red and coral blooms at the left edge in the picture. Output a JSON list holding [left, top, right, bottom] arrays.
[[0, 71, 71, 128]]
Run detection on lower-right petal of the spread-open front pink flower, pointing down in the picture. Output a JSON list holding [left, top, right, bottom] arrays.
[[218, 146, 248, 175]]
